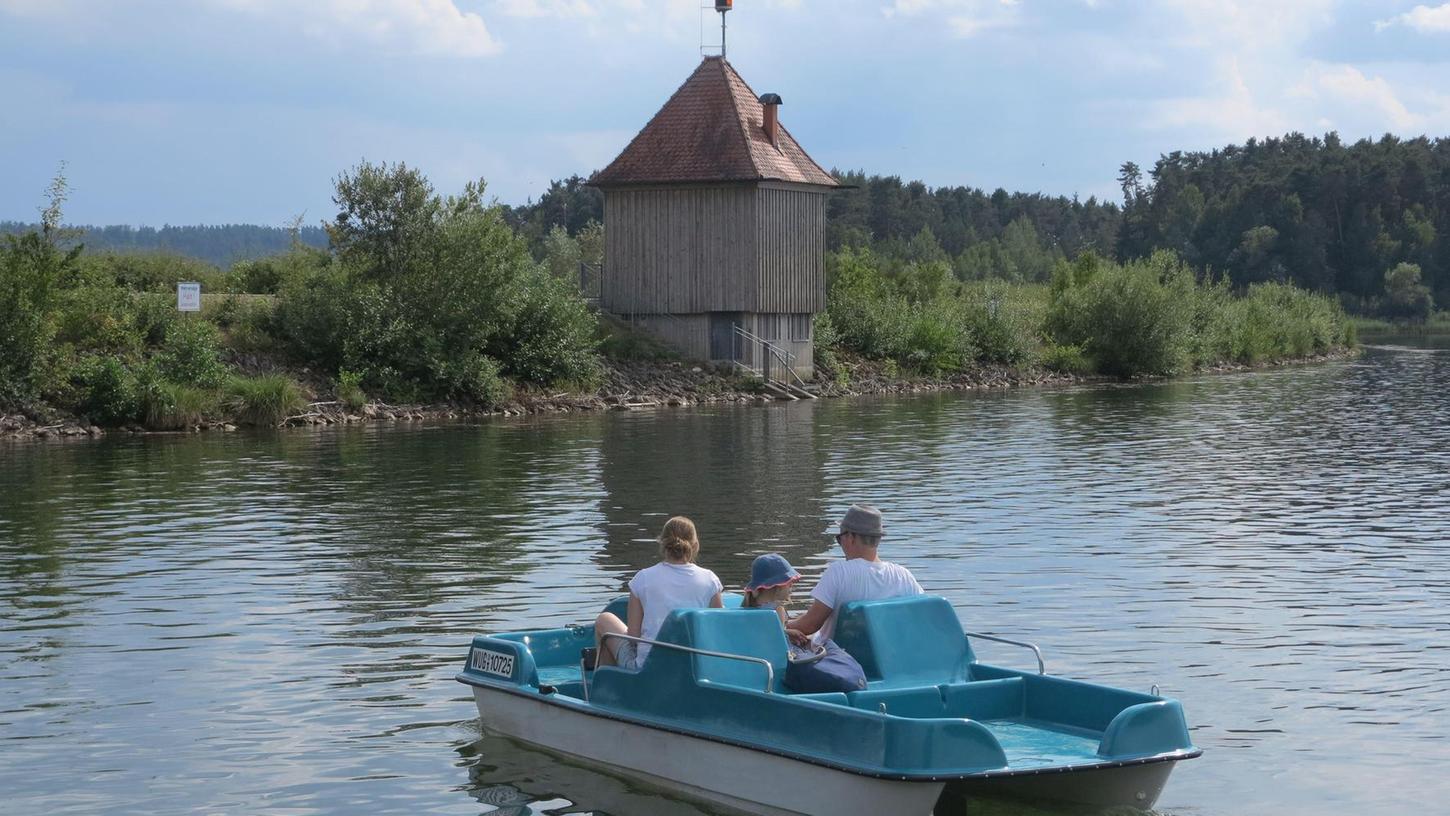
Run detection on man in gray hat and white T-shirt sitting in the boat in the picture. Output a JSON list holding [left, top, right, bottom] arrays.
[[786, 504, 922, 644]]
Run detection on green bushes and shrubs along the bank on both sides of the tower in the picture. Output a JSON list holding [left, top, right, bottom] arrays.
[[0, 155, 1357, 430]]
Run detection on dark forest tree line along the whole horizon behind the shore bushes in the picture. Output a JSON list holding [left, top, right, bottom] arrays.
[[14, 133, 1450, 317]]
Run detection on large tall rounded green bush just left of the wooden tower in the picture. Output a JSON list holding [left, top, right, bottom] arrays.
[[277, 164, 597, 401]]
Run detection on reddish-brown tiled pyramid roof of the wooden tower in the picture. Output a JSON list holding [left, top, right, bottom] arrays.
[[589, 57, 840, 187]]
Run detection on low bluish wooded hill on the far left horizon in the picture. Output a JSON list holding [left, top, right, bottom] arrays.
[[0, 220, 328, 268]]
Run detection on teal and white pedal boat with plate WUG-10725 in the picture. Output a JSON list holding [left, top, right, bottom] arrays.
[[458, 596, 1201, 815]]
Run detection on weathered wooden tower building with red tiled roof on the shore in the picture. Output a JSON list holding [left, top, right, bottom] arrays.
[[590, 57, 838, 378]]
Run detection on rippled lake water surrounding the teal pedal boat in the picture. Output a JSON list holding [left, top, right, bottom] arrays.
[[0, 341, 1450, 816]]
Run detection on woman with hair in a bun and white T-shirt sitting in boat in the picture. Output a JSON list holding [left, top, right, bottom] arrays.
[[595, 516, 724, 670]]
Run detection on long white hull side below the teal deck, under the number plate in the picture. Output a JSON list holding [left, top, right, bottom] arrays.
[[473, 686, 943, 816]]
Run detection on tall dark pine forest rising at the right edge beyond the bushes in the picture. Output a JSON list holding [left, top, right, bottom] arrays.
[[1115, 133, 1450, 316]]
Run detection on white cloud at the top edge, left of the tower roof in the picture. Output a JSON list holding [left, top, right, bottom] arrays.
[[212, 0, 500, 58]]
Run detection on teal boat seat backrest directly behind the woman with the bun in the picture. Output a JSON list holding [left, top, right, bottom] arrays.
[[648, 609, 789, 691]]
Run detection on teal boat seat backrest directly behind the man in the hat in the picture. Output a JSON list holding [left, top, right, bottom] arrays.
[[834, 596, 976, 687]]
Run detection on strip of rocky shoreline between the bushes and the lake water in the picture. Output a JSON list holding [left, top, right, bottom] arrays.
[[0, 349, 1359, 439]]
